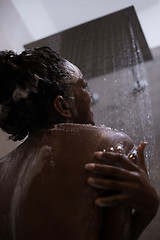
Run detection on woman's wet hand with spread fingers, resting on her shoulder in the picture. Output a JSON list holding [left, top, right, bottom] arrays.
[[85, 142, 159, 239]]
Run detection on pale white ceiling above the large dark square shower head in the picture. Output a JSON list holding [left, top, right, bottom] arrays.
[[10, 0, 160, 47]]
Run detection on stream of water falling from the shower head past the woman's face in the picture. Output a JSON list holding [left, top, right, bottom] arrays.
[[89, 25, 158, 181]]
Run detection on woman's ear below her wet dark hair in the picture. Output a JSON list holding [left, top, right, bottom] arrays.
[[53, 95, 72, 119]]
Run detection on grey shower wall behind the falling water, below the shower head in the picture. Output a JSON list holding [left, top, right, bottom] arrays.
[[88, 48, 160, 240]]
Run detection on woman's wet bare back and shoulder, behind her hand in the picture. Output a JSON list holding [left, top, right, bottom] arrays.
[[0, 124, 133, 240]]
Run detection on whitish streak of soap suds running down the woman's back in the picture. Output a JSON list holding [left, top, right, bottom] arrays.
[[10, 145, 55, 240]]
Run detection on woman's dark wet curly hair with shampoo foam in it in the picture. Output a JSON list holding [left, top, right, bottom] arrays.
[[0, 47, 76, 141]]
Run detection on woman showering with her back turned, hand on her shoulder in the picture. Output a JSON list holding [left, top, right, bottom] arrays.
[[0, 47, 159, 240]]
